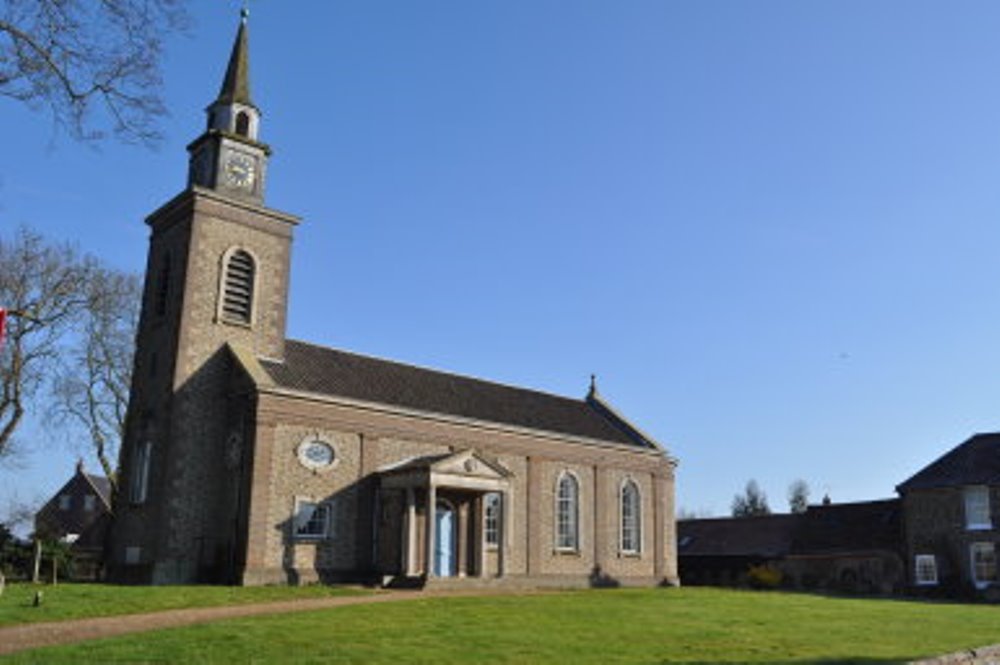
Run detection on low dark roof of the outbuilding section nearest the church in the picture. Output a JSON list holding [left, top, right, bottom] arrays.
[[677, 515, 799, 558]]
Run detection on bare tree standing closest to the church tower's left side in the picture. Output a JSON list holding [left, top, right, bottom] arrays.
[[49, 266, 142, 489]]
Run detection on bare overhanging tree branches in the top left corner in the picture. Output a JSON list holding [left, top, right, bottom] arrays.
[[0, 0, 188, 143]]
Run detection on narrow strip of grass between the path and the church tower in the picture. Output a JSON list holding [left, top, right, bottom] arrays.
[[0, 583, 362, 626]]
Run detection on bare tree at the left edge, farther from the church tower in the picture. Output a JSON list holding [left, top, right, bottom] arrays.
[[0, 228, 91, 459]]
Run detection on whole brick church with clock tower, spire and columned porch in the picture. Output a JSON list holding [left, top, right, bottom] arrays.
[[105, 13, 678, 586]]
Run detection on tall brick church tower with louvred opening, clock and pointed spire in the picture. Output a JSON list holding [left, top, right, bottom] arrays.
[[106, 10, 298, 583]]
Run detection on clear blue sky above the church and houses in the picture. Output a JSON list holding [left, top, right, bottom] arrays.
[[0, 0, 1000, 515]]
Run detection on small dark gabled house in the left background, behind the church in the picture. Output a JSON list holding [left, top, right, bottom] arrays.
[[35, 462, 111, 579]]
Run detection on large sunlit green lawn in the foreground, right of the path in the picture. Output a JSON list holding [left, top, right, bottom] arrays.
[[1, 589, 1000, 663]]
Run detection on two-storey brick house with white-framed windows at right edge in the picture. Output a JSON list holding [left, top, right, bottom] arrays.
[[896, 433, 1000, 594]]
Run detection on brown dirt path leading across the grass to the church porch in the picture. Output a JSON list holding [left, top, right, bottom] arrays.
[[0, 589, 525, 655]]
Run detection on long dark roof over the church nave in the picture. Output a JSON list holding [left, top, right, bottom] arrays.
[[260, 340, 656, 448]]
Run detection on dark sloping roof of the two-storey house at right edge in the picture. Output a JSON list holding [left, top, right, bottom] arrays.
[[896, 432, 1000, 492]]
